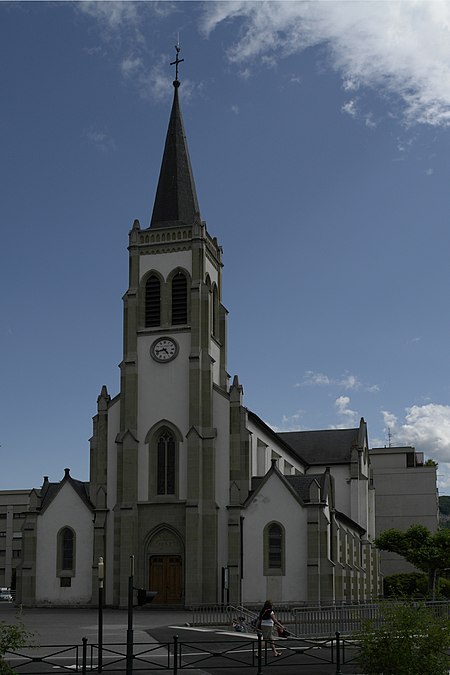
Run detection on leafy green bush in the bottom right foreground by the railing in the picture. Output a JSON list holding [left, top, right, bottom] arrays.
[[354, 603, 450, 675]]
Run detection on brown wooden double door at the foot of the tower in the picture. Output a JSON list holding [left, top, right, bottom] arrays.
[[149, 555, 183, 605]]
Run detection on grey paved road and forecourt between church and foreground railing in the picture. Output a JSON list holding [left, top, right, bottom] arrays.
[[0, 602, 357, 675]]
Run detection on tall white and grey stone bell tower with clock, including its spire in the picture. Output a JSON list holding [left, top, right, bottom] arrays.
[[91, 47, 229, 606]]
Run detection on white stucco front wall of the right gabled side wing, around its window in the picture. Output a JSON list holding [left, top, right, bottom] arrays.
[[243, 474, 307, 605]]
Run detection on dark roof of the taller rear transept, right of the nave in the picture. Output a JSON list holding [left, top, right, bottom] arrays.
[[278, 429, 359, 465]]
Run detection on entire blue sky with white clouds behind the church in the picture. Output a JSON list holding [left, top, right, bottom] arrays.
[[0, 0, 450, 494]]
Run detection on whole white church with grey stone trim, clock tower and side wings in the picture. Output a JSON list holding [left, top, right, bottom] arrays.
[[16, 56, 381, 607]]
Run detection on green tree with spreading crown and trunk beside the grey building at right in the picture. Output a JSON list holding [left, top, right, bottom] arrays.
[[375, 525, 450, 598]]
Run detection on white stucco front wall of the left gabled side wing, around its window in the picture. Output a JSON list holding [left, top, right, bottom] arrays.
[[36, 482, 93, 605]]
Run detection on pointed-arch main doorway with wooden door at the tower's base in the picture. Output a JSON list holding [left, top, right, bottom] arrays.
[[147, 528, 184, 605]]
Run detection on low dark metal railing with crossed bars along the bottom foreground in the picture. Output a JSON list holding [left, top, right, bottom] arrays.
[[0, 634, 343, 675]]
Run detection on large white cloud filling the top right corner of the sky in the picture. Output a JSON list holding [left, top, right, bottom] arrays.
[[201, 0, 450, 126]]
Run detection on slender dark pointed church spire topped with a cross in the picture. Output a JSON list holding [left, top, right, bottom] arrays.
[[150, 45, 200, 227]]
